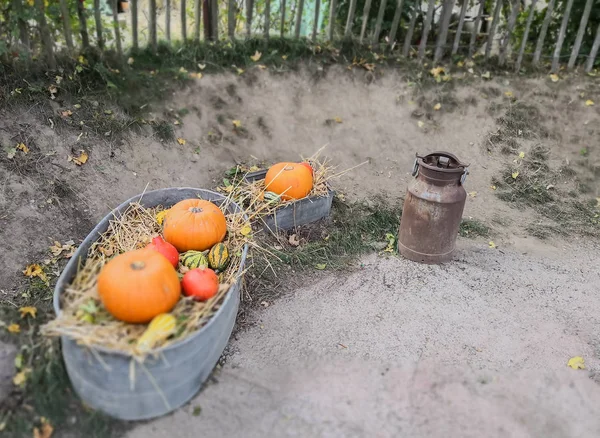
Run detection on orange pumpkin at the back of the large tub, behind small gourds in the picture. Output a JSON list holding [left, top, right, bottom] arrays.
[[163, 199, 227, 252]]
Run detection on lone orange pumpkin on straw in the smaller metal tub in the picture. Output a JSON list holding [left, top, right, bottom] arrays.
[[265, 163, 313, 200]]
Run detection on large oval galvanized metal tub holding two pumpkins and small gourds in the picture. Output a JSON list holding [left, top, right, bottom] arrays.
[[54, 188, 248, 420]]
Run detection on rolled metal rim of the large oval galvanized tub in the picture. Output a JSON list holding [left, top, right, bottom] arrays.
[[52, 187, 248, 357]]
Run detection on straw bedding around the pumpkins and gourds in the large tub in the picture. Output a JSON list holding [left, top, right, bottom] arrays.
[[43, 198, 248, 357]]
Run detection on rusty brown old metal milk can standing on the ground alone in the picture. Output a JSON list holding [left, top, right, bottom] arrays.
[[398, 152, 468, 263]]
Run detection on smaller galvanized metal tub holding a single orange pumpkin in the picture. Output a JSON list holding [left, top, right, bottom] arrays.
[[246, 170, 335, 232]]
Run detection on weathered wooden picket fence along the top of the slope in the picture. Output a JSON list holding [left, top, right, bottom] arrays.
[[0, 0, 600, 72]]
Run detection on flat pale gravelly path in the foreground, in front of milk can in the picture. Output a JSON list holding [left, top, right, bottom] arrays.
[[128, 242, 600, 438]]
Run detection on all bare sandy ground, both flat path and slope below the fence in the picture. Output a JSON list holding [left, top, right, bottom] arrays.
[[0, 68, 600, 437]]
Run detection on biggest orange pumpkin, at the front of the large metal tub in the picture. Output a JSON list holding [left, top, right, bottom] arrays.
[[98, 249, 181, 323]]
